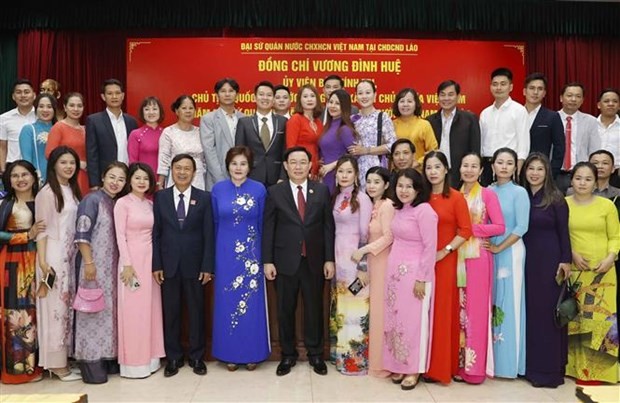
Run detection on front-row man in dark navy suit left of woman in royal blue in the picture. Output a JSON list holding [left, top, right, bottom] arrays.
[[153, 154, 214, 377]]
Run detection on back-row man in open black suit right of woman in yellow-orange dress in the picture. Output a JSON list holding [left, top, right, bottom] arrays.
[[427, 80, 480, 188]]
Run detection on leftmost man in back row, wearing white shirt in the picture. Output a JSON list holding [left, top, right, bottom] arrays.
[[0, 78, 36, 174]]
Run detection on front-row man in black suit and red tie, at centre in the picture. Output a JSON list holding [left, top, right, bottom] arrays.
[[263, 147, 335, 376]]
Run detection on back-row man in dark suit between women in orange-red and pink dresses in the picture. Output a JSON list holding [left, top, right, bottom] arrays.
[[86, 78, 138, 188]]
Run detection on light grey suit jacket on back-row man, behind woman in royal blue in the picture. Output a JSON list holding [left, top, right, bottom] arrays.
[[200, 108, 245, 191]]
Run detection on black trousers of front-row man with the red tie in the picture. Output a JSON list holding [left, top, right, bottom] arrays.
[[276, 257, 325, 358]]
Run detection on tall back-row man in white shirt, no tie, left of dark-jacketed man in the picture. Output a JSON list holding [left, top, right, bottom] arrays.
[[480, 67, 530, 186]]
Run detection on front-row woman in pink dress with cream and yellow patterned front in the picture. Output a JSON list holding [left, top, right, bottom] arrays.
[[454, 153, 505, 384]]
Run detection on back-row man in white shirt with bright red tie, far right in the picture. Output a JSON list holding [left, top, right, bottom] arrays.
[[556, 82, 601, 193]]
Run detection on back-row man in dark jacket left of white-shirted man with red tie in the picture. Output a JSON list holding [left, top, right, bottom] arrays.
[[523, 73, 566, 179]]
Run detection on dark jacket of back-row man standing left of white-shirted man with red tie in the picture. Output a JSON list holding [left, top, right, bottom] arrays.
[[530, 106, 566, 177]]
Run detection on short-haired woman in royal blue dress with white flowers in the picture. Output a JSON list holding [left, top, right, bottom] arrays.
[[211, 146, 271, 371]]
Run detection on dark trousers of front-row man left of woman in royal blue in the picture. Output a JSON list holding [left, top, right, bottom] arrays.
[[161, 272, 205, 360]]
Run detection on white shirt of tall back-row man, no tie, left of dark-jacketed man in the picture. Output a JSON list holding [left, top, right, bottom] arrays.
[[480, 97, 530, 160]]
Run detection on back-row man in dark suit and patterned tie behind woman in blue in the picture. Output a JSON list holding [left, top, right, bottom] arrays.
[[235, 81, 287, 187]]
